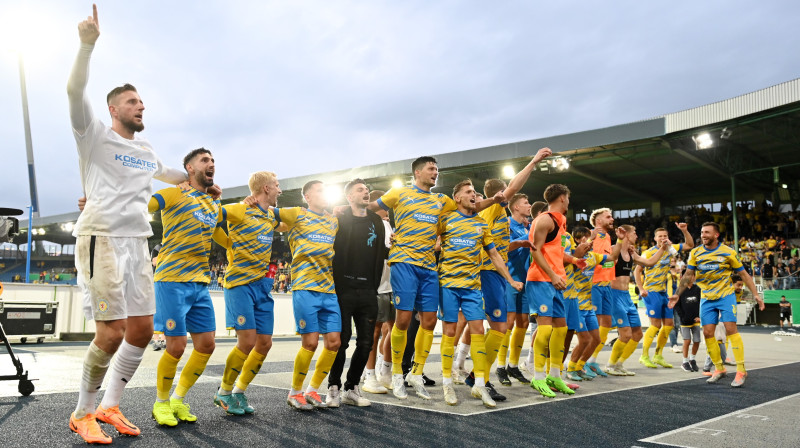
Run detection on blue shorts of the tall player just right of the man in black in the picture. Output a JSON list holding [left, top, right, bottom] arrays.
[[390, 263, 439, 312]]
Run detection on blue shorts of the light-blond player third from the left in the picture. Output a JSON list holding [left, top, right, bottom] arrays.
[[225, 277, 275, 335]]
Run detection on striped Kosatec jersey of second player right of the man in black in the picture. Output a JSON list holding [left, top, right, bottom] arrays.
[[438, 210, 494, 289]]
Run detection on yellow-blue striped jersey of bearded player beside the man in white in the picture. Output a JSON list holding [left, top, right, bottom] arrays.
[[147, 187, 224, 283]]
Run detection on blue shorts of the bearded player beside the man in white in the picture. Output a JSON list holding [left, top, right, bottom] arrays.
[[153, 282, 217, 336]]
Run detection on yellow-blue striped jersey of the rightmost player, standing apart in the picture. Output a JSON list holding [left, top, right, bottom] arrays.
[[686, 243, 744, 300]]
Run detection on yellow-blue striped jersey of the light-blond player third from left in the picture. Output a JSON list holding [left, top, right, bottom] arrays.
[[218, 204, 278, 288]]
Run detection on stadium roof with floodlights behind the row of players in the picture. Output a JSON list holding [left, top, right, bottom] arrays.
[[14, 79, 800, 244]]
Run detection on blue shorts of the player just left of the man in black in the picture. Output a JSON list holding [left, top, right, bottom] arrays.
[[292, 289, 342, 334]]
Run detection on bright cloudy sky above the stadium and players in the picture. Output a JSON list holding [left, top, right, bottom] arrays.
[[0, 0, 800, 216]]
